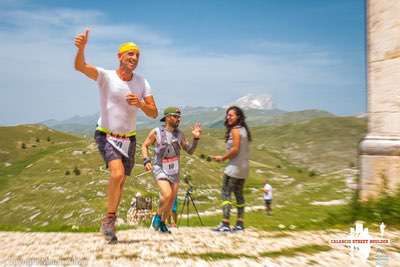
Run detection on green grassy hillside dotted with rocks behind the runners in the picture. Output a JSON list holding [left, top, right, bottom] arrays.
[[0, 118, 365, 231]]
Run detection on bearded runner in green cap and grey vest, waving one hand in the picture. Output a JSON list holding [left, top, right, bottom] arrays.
[[142, 107, 201, 233]]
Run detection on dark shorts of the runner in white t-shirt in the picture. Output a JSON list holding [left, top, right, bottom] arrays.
[[94, 130, 136, 176]]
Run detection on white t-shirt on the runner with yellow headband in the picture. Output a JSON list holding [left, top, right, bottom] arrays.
[[97, 68, 152, 134]]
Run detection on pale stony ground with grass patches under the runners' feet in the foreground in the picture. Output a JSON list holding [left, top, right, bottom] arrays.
[[0, 227, 400, 267]]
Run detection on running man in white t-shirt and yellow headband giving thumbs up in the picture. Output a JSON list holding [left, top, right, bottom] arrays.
[[75, 29, 158, 243]]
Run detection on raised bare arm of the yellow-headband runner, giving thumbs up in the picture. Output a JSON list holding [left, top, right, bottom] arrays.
[[75, 29, 99, 81]]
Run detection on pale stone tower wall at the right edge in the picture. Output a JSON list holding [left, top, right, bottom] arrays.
[[360, 0, 400, 201]]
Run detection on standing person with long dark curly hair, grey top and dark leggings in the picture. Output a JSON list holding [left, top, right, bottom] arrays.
[[213, 106, 251, 232]]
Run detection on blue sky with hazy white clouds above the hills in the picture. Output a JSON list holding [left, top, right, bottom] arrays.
[[0, 0, 366, 124]]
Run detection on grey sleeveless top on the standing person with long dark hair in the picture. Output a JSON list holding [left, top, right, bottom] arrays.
[[224, 126, 249, 179]]
